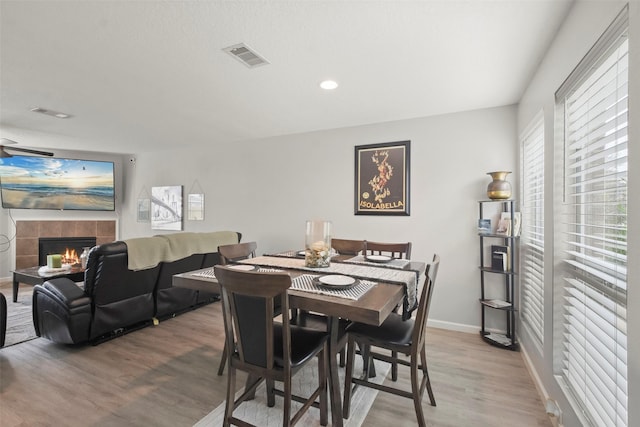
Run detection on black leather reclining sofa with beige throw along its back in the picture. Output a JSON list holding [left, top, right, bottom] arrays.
[[33, 231, 241, 344]]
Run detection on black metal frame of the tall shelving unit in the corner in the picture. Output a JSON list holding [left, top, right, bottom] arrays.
[[478, 199, 519, 350]]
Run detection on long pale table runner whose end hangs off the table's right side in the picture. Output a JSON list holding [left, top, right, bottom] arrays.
[[238, 256, 420, 319]]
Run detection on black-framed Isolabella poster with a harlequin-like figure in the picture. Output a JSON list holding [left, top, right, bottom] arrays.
[[355, 141, 411, 215]]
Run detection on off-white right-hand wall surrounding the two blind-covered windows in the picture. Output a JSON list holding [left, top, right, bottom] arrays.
[[518, 1, 640, 427]]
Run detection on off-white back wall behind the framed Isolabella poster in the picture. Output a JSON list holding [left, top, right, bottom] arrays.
[[120, 106, 516, 332]]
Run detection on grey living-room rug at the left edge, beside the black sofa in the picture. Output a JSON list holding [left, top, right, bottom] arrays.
[[2, 286, 37, 347]]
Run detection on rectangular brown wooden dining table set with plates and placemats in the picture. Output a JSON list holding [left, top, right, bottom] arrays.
[[173, 255, 426, 426]]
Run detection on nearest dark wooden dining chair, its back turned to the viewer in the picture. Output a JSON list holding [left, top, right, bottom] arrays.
[[214, 265, 328, 426]]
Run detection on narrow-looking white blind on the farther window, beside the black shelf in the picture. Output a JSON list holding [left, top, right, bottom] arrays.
[[520, 115, 544, 350]]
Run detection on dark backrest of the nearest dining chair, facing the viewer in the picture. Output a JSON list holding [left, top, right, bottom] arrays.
[[214, 266, 291, 369]]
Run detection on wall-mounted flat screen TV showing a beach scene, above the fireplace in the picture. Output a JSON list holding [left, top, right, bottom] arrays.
[[0, 156, 115, 211]]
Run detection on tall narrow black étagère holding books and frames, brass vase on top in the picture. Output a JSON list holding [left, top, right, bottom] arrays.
[[478, 199, 520, 350]]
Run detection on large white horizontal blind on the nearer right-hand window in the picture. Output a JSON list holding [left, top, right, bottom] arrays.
[[555, 9, 628, 427]]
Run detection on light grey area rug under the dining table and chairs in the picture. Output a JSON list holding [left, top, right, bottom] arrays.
[[194, 356, 390, 427]]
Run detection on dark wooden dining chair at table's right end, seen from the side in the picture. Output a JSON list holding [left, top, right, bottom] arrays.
[[343, 254, 440, 427]]
